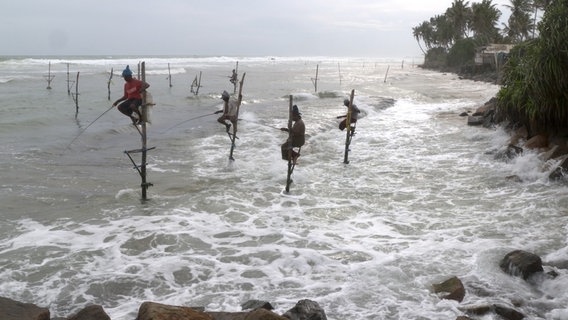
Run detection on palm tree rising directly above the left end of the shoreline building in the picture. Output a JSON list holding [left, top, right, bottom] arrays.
[[470, 0, 501, 45]]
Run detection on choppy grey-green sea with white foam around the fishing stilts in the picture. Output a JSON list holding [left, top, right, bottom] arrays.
[[0, 57, 568, 320]]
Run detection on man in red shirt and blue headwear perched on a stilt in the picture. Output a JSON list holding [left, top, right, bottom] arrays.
[[112, 66, 150, 125]]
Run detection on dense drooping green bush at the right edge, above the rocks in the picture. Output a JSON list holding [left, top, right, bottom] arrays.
[[497, 0, 568, 136]]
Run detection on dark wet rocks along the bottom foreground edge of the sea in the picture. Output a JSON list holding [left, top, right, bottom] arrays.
[[4, 250, 568, 320]]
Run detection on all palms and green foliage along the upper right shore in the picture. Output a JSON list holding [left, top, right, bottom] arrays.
[[412, 0, 568, 136]]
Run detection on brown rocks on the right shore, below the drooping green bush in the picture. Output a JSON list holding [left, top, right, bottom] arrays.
[[466, 98, 568, 180]]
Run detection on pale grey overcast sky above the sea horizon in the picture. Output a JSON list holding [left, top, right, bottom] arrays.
[[0, 0, 510, 58]]
